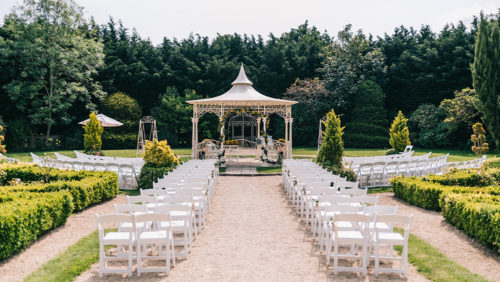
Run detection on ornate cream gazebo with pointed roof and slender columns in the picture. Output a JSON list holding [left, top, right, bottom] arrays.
[[187, 64, 298, 159]]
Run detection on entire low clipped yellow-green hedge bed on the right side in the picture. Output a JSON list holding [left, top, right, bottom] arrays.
[[391, 165, 500, 252]]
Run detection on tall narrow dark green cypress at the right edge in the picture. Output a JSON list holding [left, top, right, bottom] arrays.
[[471, 14, 500, 148]]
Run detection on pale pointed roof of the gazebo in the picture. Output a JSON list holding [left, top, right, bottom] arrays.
[[187, 64, 297, 106]]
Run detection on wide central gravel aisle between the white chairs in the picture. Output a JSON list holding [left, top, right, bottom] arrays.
[[77, 176, 425, 281]]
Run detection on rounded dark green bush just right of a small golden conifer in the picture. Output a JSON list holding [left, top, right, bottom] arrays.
[[408, 104, 450, 148]]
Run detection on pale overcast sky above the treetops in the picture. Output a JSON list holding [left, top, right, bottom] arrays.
[[0, 0, 500, 44]]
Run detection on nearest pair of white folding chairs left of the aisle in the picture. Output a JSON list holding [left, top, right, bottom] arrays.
[[96, 213, 175, 277]]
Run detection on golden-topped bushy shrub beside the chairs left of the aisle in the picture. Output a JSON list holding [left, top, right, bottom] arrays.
[[138, 139, 179, 188]]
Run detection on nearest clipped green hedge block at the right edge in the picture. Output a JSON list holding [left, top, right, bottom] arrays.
[[440, 193, 500, 253]]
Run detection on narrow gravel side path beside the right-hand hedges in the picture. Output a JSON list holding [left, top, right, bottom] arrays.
[[377, 193, 500, 281]]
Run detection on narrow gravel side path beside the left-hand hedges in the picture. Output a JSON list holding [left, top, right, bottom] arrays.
[[0, 195, 126, 282]]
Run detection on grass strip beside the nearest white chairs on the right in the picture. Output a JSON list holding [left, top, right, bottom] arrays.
[[396, 229, 488, 282]]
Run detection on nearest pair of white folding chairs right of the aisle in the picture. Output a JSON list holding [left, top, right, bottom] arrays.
[[326, 213, 413, 277]]
